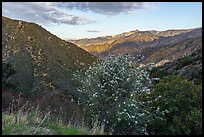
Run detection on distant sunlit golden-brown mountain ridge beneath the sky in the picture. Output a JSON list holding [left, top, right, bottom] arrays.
[[69, 28, 202, 64]]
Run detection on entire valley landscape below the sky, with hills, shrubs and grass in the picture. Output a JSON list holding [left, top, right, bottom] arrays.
[[2, 16, 202, 135]]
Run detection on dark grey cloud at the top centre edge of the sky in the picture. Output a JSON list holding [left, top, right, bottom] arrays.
[[55, 2, 150, 15]]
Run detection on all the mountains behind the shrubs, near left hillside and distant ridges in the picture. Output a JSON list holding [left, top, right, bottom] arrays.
[[2, 16, 202, 122]]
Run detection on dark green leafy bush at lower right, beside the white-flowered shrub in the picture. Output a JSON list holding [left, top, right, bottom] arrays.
[[146, 76, 202, 135]]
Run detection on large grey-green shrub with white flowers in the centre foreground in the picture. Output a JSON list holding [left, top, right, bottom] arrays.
[[75, 55, 151, 134]]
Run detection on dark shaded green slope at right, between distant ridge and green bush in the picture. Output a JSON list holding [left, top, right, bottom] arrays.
[[150, 48, 202, 85]]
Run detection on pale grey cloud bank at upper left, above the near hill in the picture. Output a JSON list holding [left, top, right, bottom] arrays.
[[2, 2, 94, 25]]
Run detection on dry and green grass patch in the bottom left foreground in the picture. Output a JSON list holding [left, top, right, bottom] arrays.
[[2, 102, 105, 135]]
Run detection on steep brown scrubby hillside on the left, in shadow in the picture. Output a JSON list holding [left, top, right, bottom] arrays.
[[2, 17, 97, 122]]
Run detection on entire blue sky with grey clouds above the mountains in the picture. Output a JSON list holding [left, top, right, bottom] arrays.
[[2, 2, 202, 40]]
